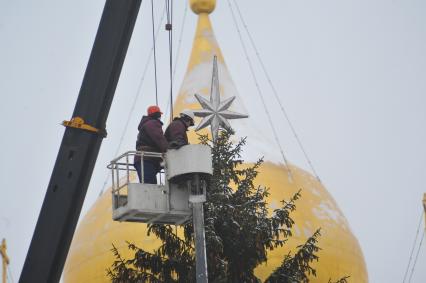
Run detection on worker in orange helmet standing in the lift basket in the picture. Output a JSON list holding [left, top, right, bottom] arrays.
[[133, 105, 168, 184]]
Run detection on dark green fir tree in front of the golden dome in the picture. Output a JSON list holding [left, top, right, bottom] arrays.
[[107, 131, 346, 283]]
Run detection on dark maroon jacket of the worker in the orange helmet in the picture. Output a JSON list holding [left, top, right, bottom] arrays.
[[135, 116, 168, 162]]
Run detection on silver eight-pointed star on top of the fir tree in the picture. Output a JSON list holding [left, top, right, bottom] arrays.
[[193, 56, 248, 141]]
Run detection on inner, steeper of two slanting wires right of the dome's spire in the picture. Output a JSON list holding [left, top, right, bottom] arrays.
[[228, 0, 293, 179]]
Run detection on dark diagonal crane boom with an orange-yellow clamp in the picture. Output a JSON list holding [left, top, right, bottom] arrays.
[[19, 0, 141, 283]]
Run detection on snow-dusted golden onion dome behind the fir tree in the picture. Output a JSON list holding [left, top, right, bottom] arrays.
[[63, 3, 368, 283]]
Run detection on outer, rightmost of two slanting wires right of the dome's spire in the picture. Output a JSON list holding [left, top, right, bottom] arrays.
[[233, 0, 321, 182]]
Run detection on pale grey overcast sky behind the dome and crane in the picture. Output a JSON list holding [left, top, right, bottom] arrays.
[[0, 0, 426, 283]]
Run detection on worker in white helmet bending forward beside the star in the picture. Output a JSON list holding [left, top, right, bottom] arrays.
[[165, 110, 194, 149]]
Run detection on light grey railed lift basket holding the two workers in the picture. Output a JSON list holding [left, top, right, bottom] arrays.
[[108, 145, 213, 225]]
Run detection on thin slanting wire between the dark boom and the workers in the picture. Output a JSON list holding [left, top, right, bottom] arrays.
[[98, 2, 166, 197]]
